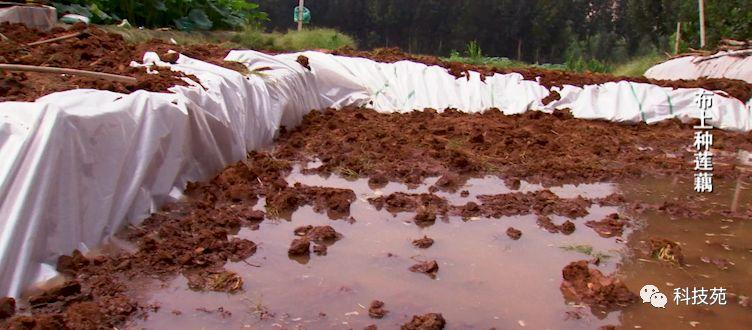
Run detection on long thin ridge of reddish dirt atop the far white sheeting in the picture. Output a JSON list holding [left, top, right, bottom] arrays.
[[333, 48, 752, 104]]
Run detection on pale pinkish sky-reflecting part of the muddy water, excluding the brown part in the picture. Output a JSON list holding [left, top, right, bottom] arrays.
[[129, 169, 626, 329]]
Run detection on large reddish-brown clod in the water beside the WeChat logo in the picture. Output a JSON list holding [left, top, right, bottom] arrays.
[[561, 260, 637, 311]]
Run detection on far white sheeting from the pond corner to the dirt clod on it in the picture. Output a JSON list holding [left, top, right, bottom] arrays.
[[262, 51, 548, 114]]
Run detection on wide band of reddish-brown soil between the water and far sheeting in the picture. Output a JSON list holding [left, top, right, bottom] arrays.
[[275, 107, 752, 187]]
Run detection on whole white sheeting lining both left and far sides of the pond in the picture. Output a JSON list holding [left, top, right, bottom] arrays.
[[0, 51, 752, 296]]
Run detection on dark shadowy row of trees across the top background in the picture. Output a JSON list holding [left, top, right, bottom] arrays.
[[253, 0, 752, 63]]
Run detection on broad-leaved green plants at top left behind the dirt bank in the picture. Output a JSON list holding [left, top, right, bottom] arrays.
[[53, 0, 267, 31]]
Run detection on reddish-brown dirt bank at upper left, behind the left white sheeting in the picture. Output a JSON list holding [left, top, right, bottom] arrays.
[[0, 23, 245, 102]]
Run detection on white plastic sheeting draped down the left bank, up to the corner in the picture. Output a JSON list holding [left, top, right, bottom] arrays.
[[0, 54, 321, 296]]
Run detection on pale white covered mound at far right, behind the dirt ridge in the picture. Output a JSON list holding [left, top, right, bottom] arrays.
[[645, 51, 752, 84]]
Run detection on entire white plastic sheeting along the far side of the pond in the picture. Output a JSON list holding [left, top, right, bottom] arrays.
[[262, 51, 752, 131]]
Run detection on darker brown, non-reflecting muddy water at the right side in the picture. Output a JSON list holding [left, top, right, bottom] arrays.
[[620, 180, 752, 329]]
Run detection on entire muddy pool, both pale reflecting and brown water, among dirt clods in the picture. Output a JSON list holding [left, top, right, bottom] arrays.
[[129, 169, 752, 329]]
